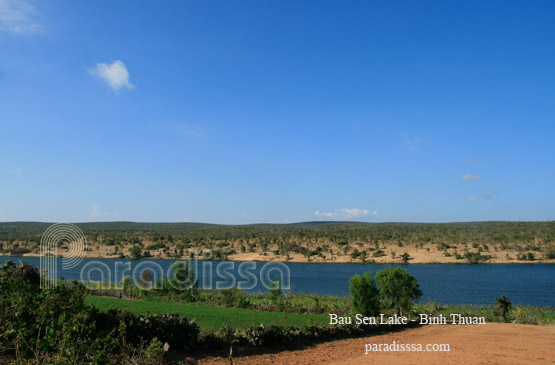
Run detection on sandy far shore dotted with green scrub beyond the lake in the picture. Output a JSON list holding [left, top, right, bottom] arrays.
[[0, 221, 555, 263]]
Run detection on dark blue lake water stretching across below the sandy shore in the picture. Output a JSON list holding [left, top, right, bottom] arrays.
[[0, 256, 555, 306]]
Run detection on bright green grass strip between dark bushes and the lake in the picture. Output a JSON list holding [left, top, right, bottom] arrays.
[[85, 296, 329, 332]]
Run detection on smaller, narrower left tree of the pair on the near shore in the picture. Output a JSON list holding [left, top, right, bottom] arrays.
[[349, 272, 380, 316]]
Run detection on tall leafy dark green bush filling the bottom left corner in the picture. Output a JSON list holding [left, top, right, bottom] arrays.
[[0, 262, 111, 362]]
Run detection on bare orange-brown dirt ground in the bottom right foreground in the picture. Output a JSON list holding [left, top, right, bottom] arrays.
[[201, 323, 555, 365]]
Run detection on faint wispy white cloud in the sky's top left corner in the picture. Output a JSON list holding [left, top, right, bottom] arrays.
[[0, 0, 42, 34]]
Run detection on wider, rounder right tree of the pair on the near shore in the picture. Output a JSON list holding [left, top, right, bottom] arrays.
[[376, 267, 422, 314]]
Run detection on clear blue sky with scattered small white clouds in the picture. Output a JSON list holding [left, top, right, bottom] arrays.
[[0, 0, 555, 224]]
